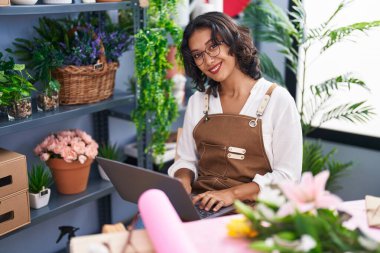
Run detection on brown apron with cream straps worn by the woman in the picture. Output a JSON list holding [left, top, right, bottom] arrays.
[[193, 84, 276, 193]]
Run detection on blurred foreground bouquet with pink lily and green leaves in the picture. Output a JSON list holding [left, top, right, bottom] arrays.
[[227, 171, 380, 253]]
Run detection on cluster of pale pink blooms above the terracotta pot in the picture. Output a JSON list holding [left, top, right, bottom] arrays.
[[34, 129, 98, 164]]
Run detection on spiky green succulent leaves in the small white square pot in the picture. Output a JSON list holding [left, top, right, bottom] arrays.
[[28, 164, 53, 193]]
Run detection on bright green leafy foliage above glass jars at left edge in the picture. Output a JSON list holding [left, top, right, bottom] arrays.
[[0, 52, 35, 106]]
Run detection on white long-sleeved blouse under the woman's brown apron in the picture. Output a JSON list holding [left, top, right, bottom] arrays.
[[168, 78, 302, 188]]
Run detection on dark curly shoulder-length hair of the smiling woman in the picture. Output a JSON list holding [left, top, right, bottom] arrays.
[[181, 12, 261, 97]]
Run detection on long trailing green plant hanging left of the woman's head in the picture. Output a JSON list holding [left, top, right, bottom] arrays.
[[132, 0, 182, 161]]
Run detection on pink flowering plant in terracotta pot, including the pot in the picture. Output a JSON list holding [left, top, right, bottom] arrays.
[[34, 129, 98, 194]]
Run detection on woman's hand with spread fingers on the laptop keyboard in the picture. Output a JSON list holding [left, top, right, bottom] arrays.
[[193, 189, 235, 212]]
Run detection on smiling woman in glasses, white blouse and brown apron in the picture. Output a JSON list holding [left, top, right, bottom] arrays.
[[168, 12, 302, 211]]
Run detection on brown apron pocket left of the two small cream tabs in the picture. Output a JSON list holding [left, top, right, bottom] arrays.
[[198, 142, 227, 176]]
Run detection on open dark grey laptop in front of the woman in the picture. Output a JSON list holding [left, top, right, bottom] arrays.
[[96, 157, 235, 221]]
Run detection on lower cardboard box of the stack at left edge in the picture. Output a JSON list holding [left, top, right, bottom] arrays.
[[0, 189, 30, 236]]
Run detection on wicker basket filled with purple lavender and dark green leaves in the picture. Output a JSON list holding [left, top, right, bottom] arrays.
[[13, 17, 131, 104]]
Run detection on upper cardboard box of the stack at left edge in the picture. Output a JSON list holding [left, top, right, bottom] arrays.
[[0, 148, 28, 198]]
